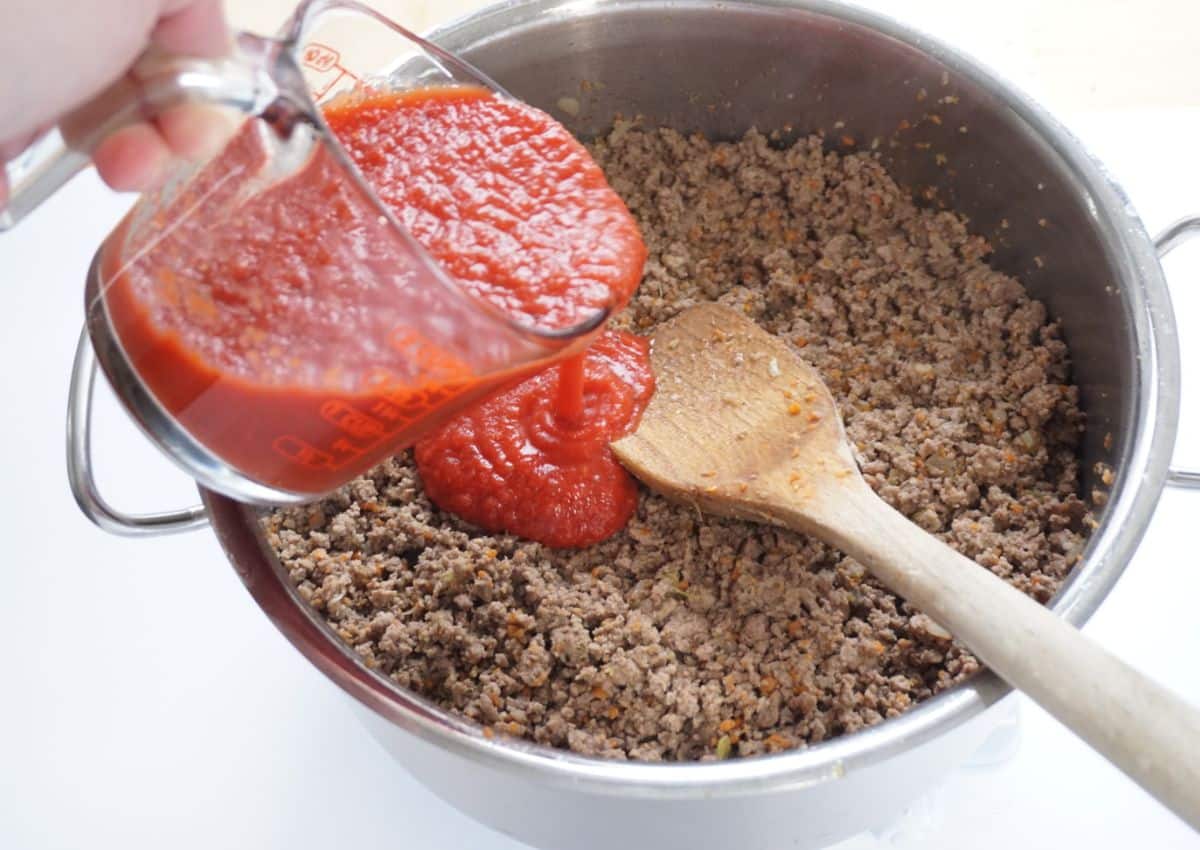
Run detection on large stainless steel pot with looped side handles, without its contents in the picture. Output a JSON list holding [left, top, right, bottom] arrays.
[[70, 0, 1200, 850]]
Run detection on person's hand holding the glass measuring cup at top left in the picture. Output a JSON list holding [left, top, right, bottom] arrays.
[[0, 0, 228, 203]]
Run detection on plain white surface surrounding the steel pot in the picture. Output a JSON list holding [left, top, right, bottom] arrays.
[[0, 0, 1200, 850]]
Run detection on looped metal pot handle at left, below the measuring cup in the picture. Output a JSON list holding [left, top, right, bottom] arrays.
[[67, 328, 208, 537]]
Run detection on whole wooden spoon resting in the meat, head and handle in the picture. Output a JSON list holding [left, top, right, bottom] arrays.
[[612, 304, 1200, 828]]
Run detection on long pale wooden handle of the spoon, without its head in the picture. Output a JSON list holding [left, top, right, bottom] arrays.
[[808, 477, 1200, 830]]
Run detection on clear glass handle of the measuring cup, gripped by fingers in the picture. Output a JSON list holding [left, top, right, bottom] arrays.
[[0, 32, 308, 231]]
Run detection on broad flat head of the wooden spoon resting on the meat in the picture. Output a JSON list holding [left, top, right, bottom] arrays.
[[612, 304, 865, 532]]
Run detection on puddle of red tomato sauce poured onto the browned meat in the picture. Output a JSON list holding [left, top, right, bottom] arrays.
[[415, 330, 654, 547]]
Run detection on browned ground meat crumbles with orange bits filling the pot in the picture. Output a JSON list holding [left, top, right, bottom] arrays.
[[264, 124, 1088, 760]]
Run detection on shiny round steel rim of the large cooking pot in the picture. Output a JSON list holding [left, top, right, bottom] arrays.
[[200, 0, 1180, 798]]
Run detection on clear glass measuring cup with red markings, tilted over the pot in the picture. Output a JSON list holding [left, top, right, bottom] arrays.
[[8, 0, 606, 528]]
